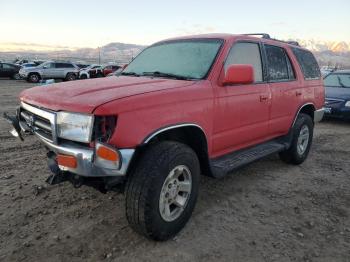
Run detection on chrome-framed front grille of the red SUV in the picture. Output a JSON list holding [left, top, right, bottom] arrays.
[[19, 103, 56, 142]]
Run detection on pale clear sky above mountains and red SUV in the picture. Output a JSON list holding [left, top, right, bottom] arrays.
[[0, 0, 350, 51]]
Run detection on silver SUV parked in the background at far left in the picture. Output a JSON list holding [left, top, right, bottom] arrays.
[[19, 61, 79, 83]]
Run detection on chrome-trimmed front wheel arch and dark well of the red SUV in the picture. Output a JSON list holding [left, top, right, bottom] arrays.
[[141, 123, 210, 175]]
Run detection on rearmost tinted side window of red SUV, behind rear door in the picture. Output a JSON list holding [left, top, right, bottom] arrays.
[[293, 48, 321, 79]]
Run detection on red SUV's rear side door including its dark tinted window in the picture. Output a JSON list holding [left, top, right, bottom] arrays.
[[264, 44, 302, 136]]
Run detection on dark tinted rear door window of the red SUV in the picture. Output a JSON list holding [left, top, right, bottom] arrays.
[[265, 45, 294, 81]]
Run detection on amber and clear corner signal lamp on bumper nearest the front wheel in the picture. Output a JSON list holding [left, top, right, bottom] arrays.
[[96, 143, 120, 169]]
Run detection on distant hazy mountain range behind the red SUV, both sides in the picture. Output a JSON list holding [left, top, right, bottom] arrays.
[[0, 39, 350, 68]]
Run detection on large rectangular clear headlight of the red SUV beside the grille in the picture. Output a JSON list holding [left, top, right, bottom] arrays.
[[57, 112, 94, 143]]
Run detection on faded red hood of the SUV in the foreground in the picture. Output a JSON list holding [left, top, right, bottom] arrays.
[[20, 76, 194, 113]]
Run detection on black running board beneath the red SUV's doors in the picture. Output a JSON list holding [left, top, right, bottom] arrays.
[[210, 140, 289, 178]]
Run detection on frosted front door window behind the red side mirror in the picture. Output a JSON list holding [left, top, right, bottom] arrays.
[[225, 43, 263, 82]]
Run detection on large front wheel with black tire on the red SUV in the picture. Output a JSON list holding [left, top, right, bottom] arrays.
[[125, 141, 200, 241]]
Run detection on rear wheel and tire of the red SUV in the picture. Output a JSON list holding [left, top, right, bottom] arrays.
[[279, 113, 314, 165]]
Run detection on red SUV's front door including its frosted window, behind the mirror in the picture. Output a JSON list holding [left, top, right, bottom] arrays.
[[212, 42, 271, 156]]
